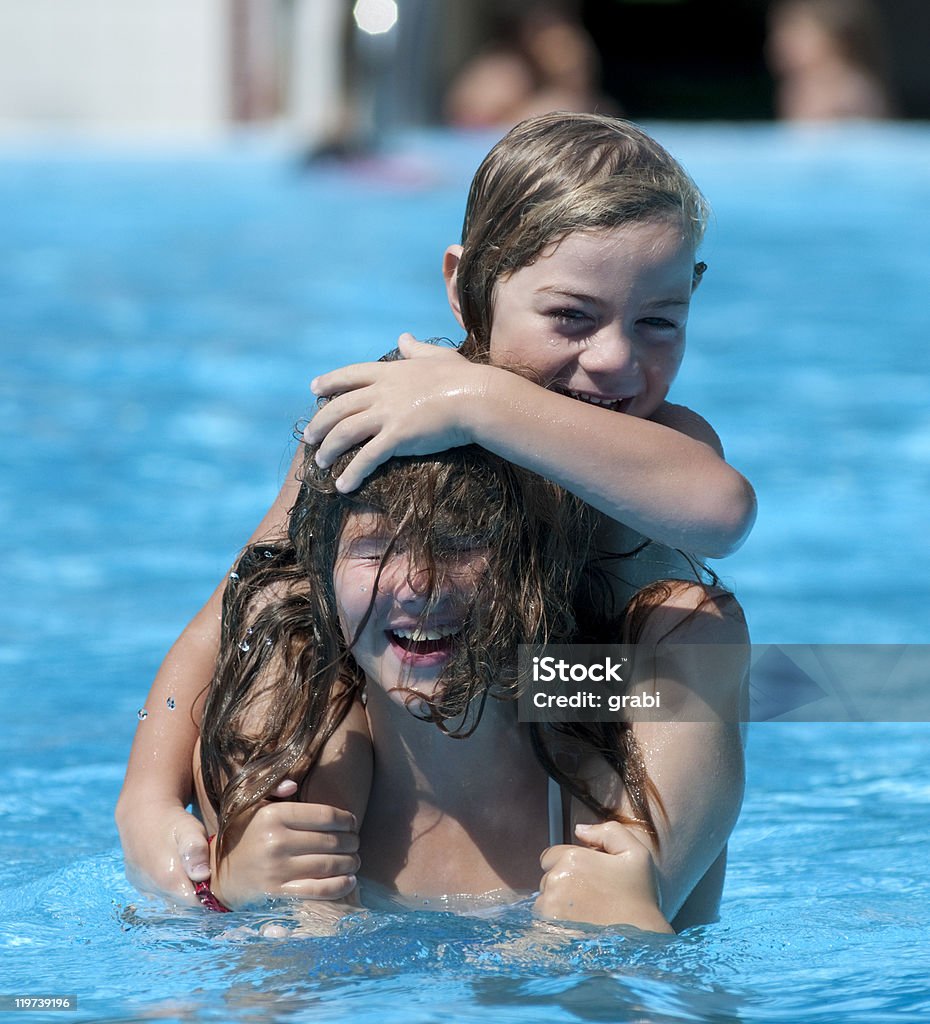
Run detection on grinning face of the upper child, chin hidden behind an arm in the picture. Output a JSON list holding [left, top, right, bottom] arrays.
[[450, 219, 694, 417]]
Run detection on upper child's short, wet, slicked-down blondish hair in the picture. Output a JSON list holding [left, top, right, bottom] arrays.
[[457, 113, 710, 360]]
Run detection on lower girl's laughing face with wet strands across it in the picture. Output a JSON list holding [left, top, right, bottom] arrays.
[[333, 512, 487, 703]]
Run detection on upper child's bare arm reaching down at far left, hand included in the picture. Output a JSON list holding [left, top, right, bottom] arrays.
[[116, 452, 303, 902]]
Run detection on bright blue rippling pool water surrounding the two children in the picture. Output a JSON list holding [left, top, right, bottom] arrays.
[[0, 126, 930, 1024]]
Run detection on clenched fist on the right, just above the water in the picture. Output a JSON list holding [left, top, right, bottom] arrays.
[[536, 821, 674, 932]]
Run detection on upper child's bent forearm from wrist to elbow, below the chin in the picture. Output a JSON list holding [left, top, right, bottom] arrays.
[[473, 367, 756, 557]]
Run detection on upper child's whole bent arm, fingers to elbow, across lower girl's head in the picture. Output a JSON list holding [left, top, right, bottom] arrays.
[[305, 339, 756, 557]]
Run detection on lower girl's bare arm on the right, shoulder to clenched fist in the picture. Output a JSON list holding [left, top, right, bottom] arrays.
[[537, 583, 749, 931]]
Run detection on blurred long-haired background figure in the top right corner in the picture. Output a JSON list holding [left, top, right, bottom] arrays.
[[765, 0, 894, 121]]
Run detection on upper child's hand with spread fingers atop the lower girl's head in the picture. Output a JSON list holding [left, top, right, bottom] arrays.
[[303, 334, 488, 492]]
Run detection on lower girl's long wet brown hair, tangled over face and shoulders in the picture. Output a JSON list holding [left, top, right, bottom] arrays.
[[201, 446, 661, 856]]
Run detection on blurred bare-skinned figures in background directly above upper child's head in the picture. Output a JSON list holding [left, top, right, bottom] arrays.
[[443, 2, 618, 128]]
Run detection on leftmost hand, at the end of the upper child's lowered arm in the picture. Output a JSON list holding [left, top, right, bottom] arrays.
[[117, 801, 210, 903]]
